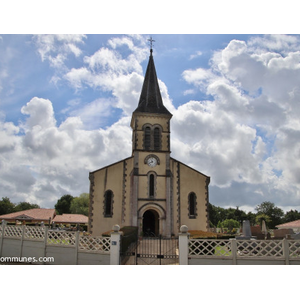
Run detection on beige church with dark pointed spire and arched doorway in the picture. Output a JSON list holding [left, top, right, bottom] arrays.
[[89, 47, 210, 237]]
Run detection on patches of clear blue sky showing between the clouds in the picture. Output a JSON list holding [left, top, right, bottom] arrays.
[[0, 34, 255, 125]]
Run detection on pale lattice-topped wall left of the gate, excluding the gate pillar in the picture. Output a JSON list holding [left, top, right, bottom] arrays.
[[0, 224, 111, 265]]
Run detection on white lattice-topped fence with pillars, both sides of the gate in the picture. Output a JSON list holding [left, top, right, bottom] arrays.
[[0, 224, 300, 265]]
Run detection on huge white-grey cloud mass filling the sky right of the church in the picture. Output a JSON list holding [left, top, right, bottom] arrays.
[[179, 36, 300, 209]]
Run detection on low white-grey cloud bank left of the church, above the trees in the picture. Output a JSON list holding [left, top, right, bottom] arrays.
[[0, 97, 131, 207]]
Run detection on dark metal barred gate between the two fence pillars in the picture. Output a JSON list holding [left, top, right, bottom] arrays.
[[121, 236, 179, 265]]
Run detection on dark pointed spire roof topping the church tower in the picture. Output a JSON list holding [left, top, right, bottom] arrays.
[[134, 49, 171, 115]]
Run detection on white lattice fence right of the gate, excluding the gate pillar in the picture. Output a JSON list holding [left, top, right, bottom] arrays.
[[188, 239, 300, 265]]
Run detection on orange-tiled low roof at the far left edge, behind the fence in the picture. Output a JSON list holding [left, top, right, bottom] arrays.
[[0, 208, 55, 221]]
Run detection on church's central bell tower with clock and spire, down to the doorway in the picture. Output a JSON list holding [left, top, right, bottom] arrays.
[[131, 45, 173, 235]]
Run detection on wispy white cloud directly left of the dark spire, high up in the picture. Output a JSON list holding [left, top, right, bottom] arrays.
[[64, 36, 149, 115]]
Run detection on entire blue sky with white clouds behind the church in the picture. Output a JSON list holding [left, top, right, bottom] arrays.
[[0, 34, 300, 211]]
